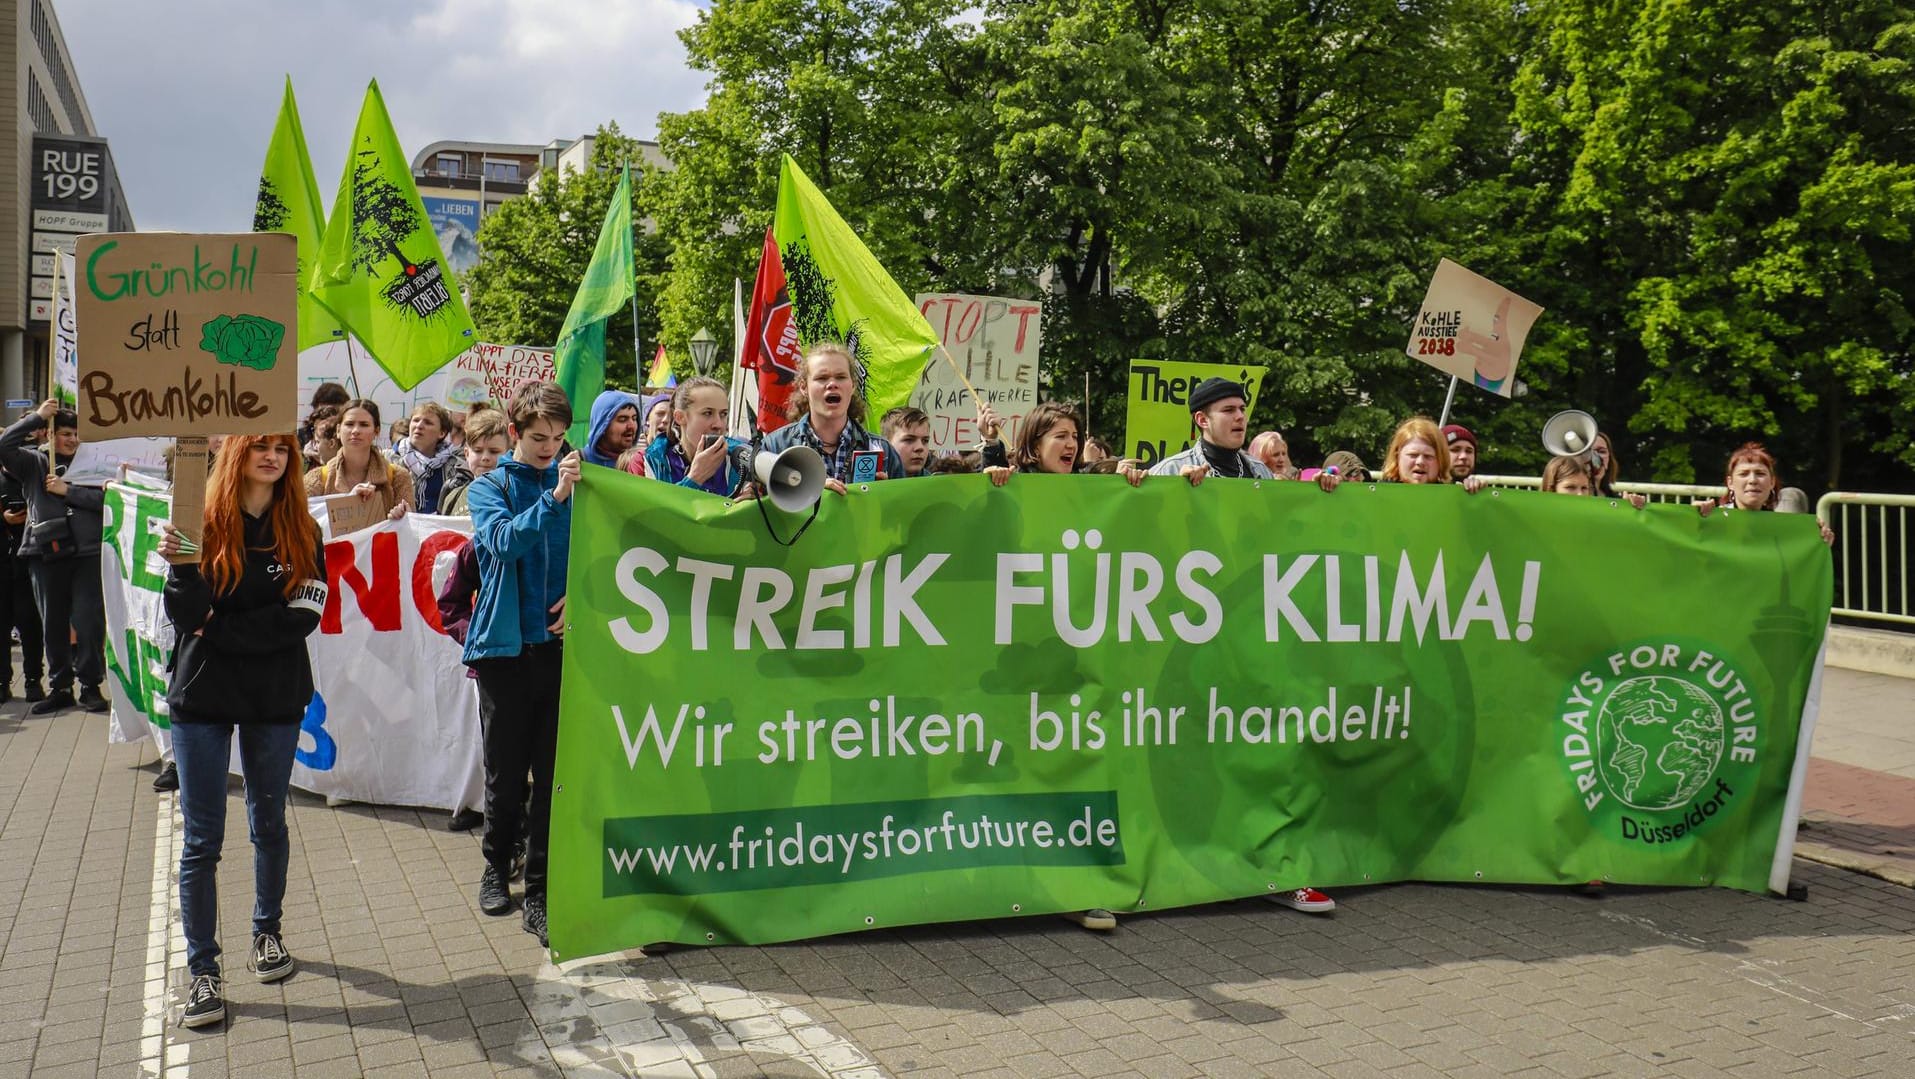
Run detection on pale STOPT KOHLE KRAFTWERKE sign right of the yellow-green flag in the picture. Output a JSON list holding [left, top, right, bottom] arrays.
[[912, 293, 1044, 450]]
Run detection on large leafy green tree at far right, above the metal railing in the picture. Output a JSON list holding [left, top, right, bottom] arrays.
[[1499, 0, 1915, 487]]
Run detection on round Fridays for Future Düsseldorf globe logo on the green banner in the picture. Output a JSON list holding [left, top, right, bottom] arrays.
[[1557, 640, 1760, 843]]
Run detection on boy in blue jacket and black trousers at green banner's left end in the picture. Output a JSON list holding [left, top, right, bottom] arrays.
[[463, 381, 578, 947]]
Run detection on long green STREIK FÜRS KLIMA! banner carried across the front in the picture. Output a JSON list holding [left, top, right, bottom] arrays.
[[550, 468, 1831, 958]]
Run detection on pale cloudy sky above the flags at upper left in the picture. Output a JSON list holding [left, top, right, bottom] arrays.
[[56, 0, 705, 232]]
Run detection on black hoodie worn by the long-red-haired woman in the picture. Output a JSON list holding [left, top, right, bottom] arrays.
[[163, 514, 326, 723]]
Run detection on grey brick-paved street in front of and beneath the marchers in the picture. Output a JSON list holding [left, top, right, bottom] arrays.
[[0, 666, 1915, 1079]]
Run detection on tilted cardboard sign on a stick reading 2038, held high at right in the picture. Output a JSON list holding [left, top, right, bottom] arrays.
[[1404, 259, 1543, 397]]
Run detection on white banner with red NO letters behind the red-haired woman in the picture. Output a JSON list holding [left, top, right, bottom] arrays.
[[100, 485, 484, 809]]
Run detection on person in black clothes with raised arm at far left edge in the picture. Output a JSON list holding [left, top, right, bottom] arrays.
[[0, 399, 111, 715]]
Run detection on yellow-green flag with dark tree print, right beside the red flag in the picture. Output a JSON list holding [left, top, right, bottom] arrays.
[[772, 153, 938, 416]]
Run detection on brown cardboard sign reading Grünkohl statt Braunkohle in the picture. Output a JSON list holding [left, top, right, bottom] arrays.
[[75, 232, 299, 439]]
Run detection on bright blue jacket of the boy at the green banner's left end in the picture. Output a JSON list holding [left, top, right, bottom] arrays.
[[463, 458, 573, 663]]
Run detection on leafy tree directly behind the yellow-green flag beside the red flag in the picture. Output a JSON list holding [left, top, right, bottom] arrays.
[[640, 0, 963, 362]]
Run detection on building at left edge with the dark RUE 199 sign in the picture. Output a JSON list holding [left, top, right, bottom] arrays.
[[0, 0, 134, 401]]
